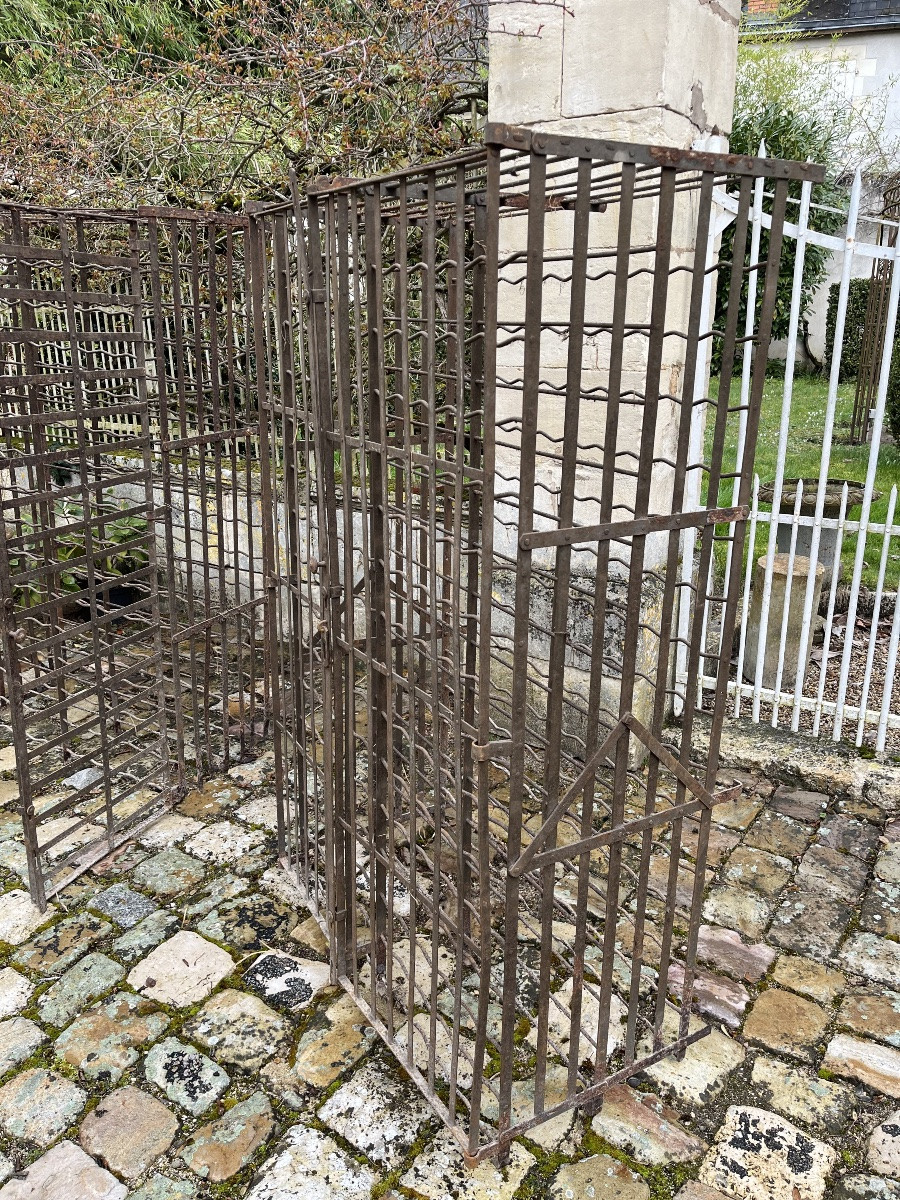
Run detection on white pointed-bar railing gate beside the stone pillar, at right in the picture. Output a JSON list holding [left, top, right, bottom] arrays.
[[676, 165, 900, 751]]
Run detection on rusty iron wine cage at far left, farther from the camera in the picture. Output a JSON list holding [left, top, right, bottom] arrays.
[[0, 204, 268, 906]]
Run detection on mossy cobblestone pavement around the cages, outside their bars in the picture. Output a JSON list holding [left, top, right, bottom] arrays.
[[0, 757, 900, 1200]]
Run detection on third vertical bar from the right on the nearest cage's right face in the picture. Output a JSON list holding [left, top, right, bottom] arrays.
[[625, 172, 715, 1061]]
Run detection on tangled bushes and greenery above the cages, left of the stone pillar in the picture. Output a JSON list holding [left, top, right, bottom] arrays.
[[0, 0, 486, 208]]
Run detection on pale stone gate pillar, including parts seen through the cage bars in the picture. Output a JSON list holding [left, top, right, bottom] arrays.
[[488, 0, 740, 736]]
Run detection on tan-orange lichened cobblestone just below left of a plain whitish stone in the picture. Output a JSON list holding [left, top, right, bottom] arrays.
[[55, 991, 169, 1084]]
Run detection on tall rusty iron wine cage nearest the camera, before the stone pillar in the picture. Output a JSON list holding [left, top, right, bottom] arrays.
[[255, 125, 822, 1162]]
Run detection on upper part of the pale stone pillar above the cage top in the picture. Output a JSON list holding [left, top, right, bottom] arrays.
[[487, 0, 740, 150]]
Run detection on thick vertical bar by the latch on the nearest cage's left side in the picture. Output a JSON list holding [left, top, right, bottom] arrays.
[[307, 197, 350, 964]]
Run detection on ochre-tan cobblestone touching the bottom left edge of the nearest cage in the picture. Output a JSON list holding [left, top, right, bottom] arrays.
[[262, 994, 377, 1109]]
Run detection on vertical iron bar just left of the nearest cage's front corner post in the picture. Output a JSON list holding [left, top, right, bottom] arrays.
[[448, 167, 472, 1123]]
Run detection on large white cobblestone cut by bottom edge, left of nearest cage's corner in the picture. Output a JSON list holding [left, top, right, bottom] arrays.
[[247, 1124, 378, 1200]]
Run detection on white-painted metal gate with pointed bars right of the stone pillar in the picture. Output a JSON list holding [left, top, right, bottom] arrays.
[[676, 165, 900, 752]]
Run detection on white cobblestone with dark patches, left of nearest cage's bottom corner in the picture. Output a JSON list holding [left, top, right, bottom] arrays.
[[318, 1063, 434, 1169]]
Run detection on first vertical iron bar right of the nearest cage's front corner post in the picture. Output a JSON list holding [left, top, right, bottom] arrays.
[[498, 145, 547, 1158]]
